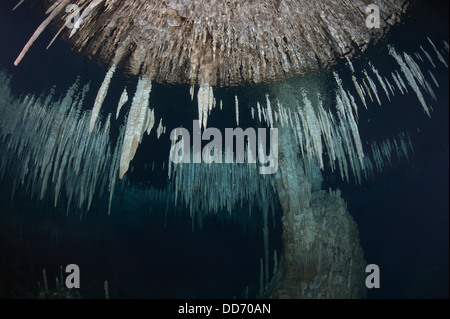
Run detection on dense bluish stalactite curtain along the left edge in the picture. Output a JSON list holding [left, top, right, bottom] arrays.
[[0, 71, 123, 214]]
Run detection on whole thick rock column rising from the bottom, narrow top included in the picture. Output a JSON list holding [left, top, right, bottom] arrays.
[[268, 122, 366, 299]]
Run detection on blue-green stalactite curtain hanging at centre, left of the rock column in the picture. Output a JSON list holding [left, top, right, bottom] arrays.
[[169, 152, 276, 230]]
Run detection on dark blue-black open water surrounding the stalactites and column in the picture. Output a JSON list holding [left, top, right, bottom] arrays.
[[0, 0, 449, 298]]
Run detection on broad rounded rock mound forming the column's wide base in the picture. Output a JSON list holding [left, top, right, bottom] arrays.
[[263, 190, 366, 299]]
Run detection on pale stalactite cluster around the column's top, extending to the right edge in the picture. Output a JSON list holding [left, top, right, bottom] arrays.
[[244, 39, 445, 183]]
